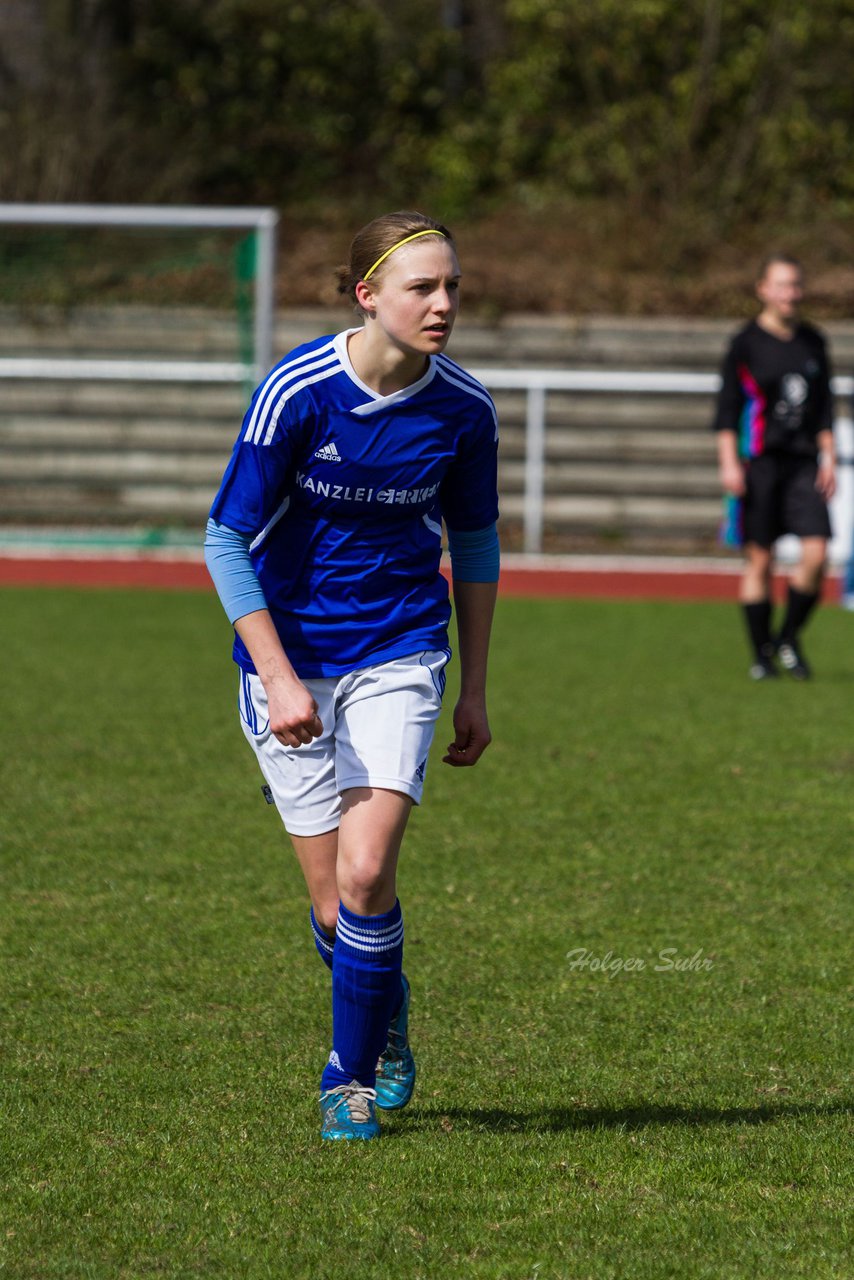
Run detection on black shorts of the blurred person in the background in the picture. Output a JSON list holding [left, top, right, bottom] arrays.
[[744, 453, 831, 547]]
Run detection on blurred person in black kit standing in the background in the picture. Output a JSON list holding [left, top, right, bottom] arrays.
[[714, 253, 835, 680]]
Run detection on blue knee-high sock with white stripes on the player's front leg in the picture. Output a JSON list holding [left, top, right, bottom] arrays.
[[320, 902, 403, 1089]]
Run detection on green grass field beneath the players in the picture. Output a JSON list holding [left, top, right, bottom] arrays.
[[0, 590, 854, 1280]]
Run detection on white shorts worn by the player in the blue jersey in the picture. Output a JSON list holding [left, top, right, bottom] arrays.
[[238, 649, 451, 836]]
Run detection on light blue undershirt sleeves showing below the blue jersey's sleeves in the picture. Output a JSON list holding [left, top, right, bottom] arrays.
[[205, 520, 501, 622]]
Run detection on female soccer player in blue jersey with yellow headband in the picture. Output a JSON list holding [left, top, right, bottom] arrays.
[[205, 212, 498, 1139]]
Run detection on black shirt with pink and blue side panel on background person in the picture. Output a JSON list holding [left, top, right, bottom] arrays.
[[714, 320, 834, 458]]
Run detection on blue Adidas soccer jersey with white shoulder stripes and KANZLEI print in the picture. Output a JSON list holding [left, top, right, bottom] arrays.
[[211, 330, 498, 678]]
